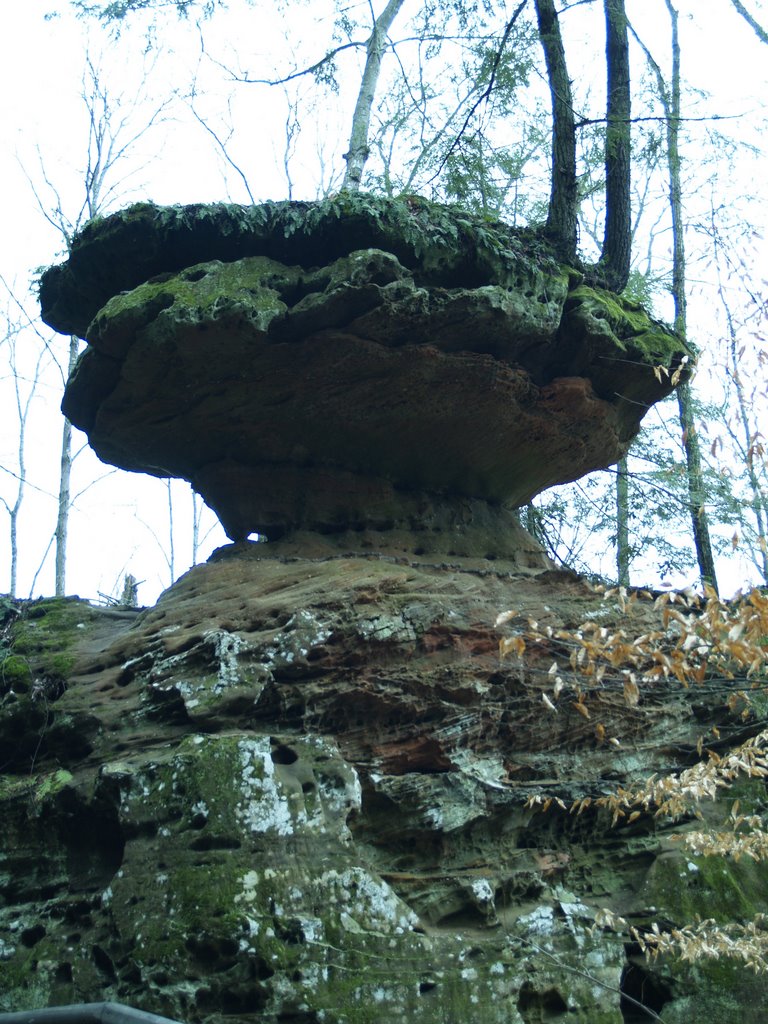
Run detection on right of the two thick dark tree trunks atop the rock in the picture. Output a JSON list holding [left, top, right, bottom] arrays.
[[598, 0, 632, 292]]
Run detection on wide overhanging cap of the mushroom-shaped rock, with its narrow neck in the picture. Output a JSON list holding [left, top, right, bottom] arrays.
[[41, 196, 685, 555]]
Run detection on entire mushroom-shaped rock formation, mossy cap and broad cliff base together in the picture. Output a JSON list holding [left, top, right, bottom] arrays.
[[6, 195, 741, 1024]]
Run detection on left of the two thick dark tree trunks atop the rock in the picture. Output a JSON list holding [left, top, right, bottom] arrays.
[[536, 0, 579, 261]]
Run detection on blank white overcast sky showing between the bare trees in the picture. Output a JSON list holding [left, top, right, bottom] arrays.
[[0, 0, 768, 603]]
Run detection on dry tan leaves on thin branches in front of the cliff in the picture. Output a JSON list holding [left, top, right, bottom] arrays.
[[497, 588, 768, 973]]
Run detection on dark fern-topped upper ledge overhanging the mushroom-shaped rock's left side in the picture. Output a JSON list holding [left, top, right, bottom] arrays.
[[40, 193, 573, 337]]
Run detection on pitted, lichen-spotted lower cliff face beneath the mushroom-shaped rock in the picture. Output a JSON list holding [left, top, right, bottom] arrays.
[[0, 557, 766, 1024]]
